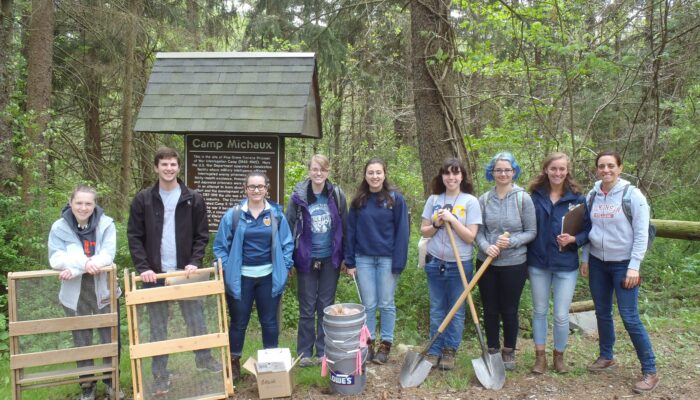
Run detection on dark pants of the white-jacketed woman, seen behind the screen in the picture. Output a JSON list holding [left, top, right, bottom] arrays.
[[63, 274, 121, 386]]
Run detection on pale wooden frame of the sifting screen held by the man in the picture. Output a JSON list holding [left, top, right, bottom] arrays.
[[124, 265, 234, 400]]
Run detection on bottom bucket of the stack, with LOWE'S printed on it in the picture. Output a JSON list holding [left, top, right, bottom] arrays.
[[326, 347, 367, 395]]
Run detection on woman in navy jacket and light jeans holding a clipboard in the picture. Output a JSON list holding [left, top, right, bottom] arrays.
[[527, 153, 591, 374]]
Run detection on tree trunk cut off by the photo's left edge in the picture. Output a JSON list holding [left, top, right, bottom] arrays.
[[0, 0, 17, 195]]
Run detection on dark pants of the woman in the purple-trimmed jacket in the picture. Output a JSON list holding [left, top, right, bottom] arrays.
[[297, 257, 340, 357]]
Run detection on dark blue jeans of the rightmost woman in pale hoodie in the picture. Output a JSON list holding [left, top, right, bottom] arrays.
[[588, 256, 656, 374]]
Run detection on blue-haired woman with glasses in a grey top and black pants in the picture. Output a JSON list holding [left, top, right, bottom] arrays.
[[476, 152, 537, 370]]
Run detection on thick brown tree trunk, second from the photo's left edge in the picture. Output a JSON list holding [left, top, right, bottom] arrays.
[[22, 0, 54, 202]]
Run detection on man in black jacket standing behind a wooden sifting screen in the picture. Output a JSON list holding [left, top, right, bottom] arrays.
[[127, 147, 221, 395]]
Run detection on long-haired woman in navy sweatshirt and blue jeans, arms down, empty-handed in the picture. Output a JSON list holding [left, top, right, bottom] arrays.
[[345, 158, 409, 364]]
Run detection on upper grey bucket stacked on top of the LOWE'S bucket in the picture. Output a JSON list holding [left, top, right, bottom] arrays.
[[323, 303, 367, 352]]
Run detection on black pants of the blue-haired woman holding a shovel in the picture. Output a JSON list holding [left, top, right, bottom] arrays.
[[476, 260, 527, 349]]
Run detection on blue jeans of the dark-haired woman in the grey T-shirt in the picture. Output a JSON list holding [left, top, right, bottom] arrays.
[[425, 258, 472, 356]]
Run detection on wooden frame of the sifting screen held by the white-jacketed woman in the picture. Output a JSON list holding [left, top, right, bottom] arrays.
[[7, 265, 119, 400]]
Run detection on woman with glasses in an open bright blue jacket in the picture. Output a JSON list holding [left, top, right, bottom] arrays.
[[214, 172, 294, 379]]
